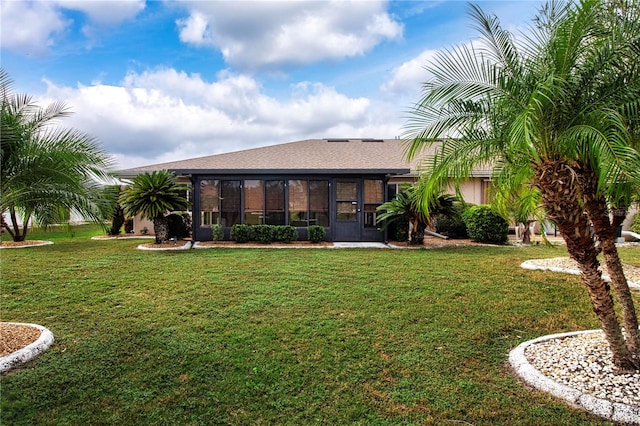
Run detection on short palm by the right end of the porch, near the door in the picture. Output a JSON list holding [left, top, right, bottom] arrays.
[[378, 186, 456, 245]]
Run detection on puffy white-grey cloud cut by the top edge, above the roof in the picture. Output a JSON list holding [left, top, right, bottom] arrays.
[[176, 1, 403, 68]]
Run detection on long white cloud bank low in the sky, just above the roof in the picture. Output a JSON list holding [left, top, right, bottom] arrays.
[[41, 69, 399, 168]]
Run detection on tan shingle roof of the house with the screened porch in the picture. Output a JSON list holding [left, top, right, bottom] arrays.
[[119, 139, 422, 177]]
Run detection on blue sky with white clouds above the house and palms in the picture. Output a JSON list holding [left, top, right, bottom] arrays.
[[0, 0, 542, 169]]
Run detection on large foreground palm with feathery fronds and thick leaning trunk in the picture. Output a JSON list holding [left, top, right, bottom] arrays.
[[407, 0, 640, 370]]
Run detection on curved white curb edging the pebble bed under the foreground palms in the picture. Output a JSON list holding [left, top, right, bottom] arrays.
[[509, 330, 640, 425]]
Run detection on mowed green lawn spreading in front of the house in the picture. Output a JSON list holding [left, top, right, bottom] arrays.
[[0, 227, 640, 425]]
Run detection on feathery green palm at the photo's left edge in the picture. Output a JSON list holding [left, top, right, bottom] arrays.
[[0, 69, 113, 241]]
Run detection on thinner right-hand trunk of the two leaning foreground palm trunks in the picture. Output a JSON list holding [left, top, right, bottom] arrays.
[[576, 167, 640, 360]]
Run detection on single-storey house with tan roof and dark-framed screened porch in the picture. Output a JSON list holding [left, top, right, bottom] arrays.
[[119, 138, 491, 241]]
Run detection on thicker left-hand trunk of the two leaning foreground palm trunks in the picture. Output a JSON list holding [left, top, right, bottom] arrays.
[[535, 160, 638, 371]]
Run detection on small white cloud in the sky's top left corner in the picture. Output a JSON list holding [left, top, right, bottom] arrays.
[[0, 1, 71, 56]]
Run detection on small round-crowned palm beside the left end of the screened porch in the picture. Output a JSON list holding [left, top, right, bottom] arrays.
[[119, 170, 188, 244]]
